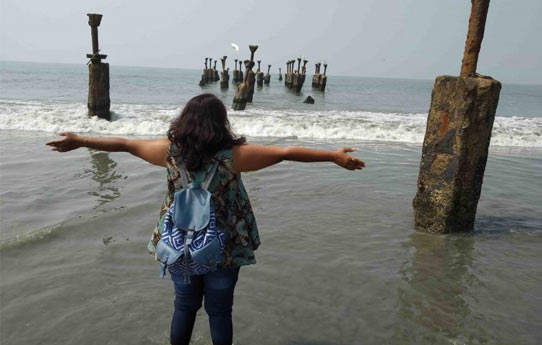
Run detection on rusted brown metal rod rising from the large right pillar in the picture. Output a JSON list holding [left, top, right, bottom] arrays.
[[461, 0, 489, 77]]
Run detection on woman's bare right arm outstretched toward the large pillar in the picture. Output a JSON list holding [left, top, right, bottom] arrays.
[[233, 144, 365, 173]]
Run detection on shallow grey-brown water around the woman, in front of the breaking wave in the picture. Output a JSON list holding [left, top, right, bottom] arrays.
[[0, 131, 542, 345]]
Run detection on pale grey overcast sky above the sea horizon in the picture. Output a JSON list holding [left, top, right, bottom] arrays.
[[0, 0, 542, 84]]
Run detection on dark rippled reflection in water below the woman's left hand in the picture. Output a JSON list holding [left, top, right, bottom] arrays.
[[87, 150, 125, 209]]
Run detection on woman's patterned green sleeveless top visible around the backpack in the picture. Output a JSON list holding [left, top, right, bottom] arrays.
[[147, 145, 260, 267]]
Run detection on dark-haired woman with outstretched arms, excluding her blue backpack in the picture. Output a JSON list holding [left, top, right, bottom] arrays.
[[47, 94, 365, 345]]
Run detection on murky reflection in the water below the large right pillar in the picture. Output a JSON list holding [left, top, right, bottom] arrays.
[[393, 232, 477, 344]]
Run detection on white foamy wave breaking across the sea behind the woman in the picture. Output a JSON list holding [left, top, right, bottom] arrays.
[[0, 101, 542, 147]]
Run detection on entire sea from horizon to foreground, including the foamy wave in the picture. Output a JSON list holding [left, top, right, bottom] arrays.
[[0, 62, 542, 345]]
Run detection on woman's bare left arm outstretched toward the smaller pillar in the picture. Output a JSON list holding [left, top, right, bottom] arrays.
[[45, 132, 170, 167]]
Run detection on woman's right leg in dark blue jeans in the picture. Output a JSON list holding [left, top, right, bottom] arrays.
[[203, 268, 239, 345]]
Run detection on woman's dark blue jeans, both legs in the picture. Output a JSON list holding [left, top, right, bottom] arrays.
[[170, 267, 239, 345]]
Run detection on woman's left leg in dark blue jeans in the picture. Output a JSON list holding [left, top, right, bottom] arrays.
[[170, 274, 203, 345]]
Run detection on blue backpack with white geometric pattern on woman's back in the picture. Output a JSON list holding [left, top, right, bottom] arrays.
[[156, 162, 225, 283]]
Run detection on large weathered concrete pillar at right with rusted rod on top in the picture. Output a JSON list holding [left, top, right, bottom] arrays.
[[413, 0, 501, 233]]
